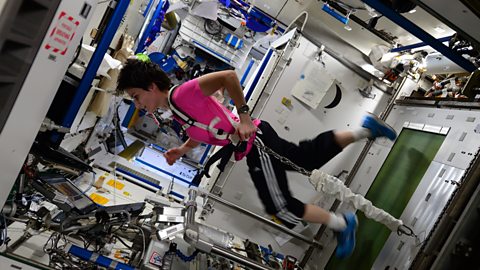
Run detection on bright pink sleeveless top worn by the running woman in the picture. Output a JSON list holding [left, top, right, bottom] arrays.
[[172, 79, 260, 160]]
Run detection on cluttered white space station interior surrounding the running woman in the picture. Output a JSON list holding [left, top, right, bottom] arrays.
[[0, 0, 480, 270]]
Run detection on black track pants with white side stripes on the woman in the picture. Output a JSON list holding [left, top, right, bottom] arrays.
[[247, 121, 342, 228]]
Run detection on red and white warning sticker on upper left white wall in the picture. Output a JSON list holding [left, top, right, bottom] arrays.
[[45, 11, 80, 55]]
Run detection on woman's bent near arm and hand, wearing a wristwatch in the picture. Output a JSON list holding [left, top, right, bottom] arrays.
[[198, 70, 257, 140]]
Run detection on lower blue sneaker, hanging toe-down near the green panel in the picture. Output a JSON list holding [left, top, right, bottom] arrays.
[[335, 212, 358, 259]]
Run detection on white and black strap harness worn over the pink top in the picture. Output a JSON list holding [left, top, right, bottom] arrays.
[[168, 85, 247, 186]]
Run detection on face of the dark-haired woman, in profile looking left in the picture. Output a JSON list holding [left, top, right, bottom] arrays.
[[126, 84, 168, 113]]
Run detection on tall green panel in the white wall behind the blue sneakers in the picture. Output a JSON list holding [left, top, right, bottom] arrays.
[[326, 128, 445, 270]]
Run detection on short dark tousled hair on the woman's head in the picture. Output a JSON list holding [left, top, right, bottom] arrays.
[[117, 59, 171, 94]]
